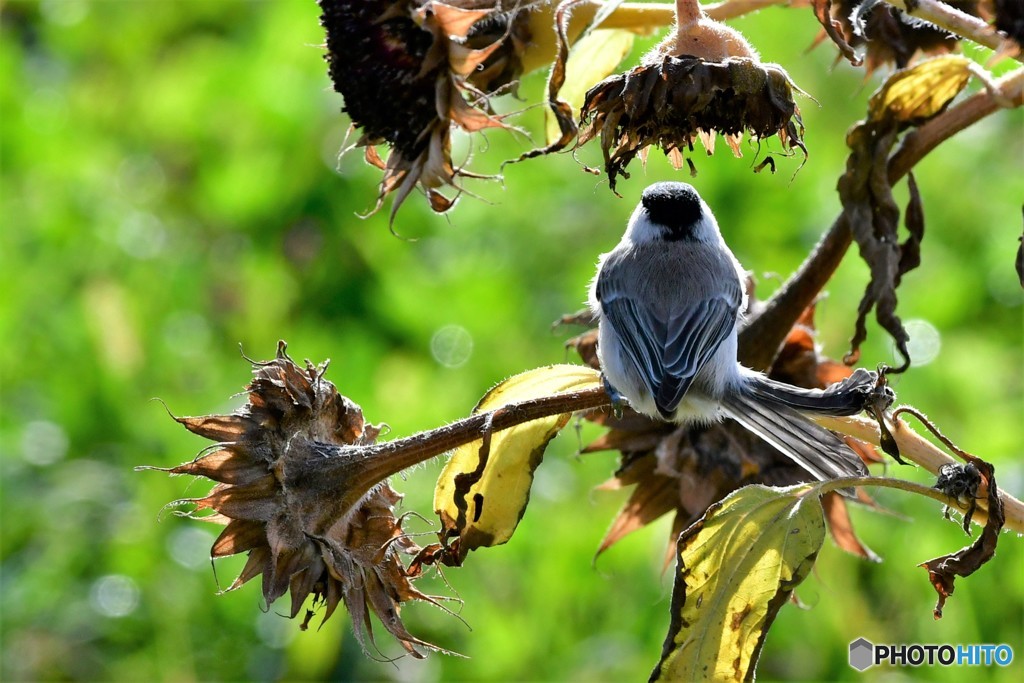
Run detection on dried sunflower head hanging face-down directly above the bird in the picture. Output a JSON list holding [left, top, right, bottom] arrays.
[[578, 0, 807, 190]]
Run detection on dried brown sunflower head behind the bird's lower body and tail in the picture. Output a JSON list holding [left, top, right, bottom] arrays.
[[569, 301, 882, 560]]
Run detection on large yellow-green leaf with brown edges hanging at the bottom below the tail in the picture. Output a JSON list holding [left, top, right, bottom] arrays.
[[651, 484, 825, 681]]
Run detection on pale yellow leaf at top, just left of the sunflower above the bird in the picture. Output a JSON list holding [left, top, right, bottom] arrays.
[[546, 29, 634, 144]]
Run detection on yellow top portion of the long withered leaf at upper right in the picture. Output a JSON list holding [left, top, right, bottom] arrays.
[[868, 54, 974, 123]]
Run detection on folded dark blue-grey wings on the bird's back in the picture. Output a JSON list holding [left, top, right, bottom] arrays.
[[597, 269, 741, 420]]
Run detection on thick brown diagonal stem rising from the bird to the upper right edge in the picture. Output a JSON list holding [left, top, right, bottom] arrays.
[[739, 69, 1024, 370]]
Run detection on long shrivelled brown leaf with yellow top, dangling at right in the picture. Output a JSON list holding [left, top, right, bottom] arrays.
[[839, 55, 974, 372]]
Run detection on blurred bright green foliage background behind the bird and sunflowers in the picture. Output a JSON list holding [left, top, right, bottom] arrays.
[[0, 0, 1024, 681]]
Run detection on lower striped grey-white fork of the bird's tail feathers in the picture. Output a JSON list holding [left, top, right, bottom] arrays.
[[722, 392, 867, 481]]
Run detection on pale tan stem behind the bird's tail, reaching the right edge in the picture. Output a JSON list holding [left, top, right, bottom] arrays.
[[814, 417, 1024, 533]]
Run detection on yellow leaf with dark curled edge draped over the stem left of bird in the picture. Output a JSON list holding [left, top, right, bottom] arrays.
[[434, 365, 601, 556]]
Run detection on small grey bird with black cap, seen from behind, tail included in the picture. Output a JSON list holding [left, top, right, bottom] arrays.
[[590, 182, 876, 479]]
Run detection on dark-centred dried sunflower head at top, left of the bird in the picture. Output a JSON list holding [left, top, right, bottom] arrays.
[[318, 0, 538, 220]]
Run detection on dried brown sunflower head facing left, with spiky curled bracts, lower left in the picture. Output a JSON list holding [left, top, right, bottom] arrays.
[[143, 342, 452, 656]]
